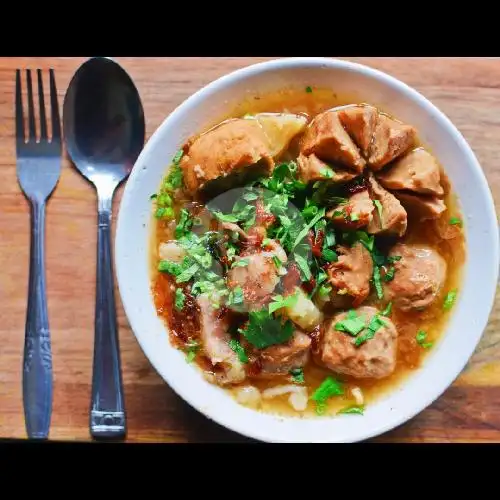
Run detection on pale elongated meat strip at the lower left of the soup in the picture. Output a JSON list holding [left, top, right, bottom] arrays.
[[196, 294, 246, 385]]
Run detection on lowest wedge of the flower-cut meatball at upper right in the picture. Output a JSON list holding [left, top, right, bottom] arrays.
[[367, 175, 408, 236]]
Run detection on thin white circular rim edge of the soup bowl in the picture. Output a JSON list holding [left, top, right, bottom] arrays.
[[114, 57, 500, 442]]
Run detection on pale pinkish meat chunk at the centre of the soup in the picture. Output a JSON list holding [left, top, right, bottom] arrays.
[[227, 241, 287, 311]]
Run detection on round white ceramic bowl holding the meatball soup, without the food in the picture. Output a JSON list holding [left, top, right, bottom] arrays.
[[115, 58, 499, 442]]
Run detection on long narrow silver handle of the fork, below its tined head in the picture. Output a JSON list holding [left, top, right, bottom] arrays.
[[23, 201, 52, 439]]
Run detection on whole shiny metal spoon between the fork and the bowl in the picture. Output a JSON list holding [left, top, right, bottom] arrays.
[[63, 57, 145, 438]]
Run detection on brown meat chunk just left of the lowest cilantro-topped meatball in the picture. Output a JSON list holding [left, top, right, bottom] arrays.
[[258, 330, 311, 377]]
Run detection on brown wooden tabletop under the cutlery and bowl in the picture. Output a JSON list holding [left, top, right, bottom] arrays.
[[0, 58, 500, 442]]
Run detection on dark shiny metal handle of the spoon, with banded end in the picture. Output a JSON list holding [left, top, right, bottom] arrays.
[[90, 191, 126, 439]]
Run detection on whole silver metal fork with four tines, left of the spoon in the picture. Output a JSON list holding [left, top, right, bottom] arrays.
[[16, 69, 61, 439]]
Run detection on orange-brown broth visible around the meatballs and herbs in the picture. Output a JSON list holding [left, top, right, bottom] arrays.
[[150, 88, 465, 418]]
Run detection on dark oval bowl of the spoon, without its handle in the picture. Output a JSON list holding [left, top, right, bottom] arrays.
[[64, 57, 145, 188]]
